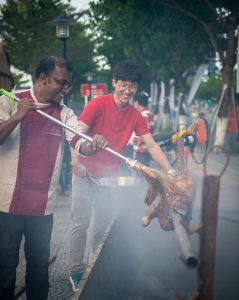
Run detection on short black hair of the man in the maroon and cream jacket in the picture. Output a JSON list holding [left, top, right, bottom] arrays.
[[35, 56, 72, 79]]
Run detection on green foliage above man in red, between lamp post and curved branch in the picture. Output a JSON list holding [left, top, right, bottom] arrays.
[[88, 0, 213, 92]]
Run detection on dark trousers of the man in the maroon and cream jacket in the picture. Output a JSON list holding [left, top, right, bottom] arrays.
[[0, 212, 53, 300]]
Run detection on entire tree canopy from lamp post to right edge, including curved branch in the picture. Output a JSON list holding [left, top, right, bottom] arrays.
[[85, 0, 239, 115]]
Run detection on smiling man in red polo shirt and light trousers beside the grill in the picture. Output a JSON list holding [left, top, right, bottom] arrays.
[[70, 61, 176, 291]]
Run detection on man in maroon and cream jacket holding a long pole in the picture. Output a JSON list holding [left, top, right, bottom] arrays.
[[0, 56, 107, 300]]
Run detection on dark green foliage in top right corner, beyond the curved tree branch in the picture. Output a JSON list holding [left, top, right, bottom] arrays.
[[160, 0, 239, 64]]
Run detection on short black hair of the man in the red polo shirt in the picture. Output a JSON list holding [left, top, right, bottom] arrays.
[[113, 60, 142, 83]]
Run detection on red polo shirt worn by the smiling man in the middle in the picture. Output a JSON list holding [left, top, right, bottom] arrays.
[[79, 94, 150, 177]]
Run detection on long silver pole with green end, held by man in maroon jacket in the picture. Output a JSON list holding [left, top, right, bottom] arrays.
[[0, 89, 129, 161]]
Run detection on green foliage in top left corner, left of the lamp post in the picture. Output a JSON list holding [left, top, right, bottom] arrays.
[[0, 0, 65, 75]]
